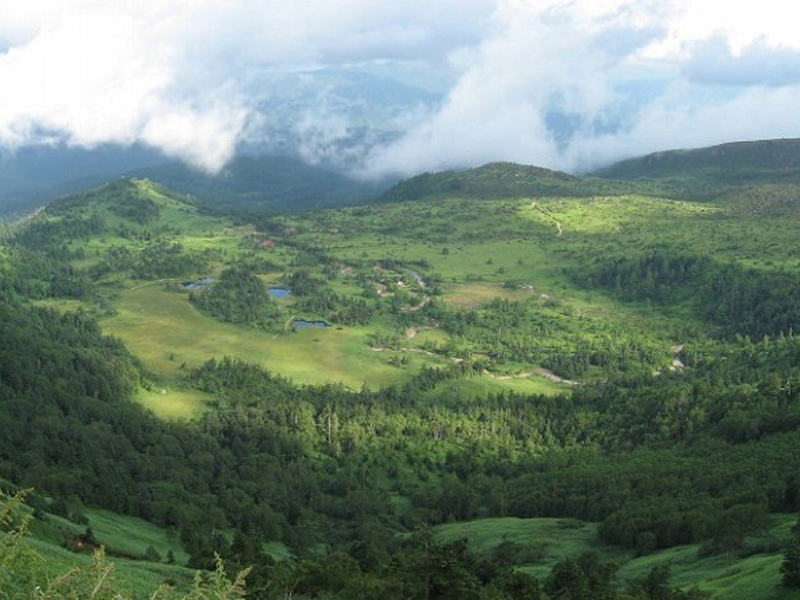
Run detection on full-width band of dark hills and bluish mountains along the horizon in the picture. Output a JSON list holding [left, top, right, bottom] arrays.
[[0, 139, 800, 216]]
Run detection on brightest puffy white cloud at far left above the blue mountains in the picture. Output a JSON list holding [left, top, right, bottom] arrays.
[[0, 5, 243, 170]]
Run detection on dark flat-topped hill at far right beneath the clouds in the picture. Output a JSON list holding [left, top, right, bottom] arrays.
[[595, 139, 800, 183]]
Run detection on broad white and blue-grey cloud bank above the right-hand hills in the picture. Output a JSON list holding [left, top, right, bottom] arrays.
[[368, 0, 800, 175]]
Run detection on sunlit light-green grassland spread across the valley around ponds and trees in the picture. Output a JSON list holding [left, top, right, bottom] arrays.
[[59, 182, 796, 418]]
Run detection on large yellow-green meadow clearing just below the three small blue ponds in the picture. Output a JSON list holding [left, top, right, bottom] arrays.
[[104, 286, 428, 389]]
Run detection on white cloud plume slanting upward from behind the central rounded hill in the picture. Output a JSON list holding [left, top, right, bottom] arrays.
[[367, 2, 664, 175]]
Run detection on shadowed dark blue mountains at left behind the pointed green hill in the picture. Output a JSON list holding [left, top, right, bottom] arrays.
[[0, 147, 385, 217]]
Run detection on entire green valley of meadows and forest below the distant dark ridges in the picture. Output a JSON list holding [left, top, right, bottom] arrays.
[[0, 156, 800, 600]]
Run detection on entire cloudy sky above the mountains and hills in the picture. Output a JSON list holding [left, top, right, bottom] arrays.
[[0, 0, 800, 177]]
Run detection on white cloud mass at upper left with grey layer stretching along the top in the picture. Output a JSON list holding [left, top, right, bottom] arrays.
[[0, 0, 492, 170]]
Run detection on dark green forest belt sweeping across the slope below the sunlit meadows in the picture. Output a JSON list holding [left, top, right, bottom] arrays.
[[0, 290, 800, 597]]
